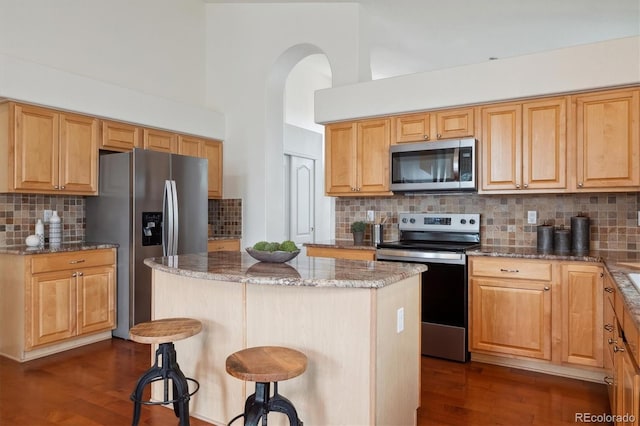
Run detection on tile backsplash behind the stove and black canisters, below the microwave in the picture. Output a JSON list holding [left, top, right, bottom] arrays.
[[336, 192, 640, 251]]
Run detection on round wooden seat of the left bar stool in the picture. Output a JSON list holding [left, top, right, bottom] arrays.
[[129, 318, 202, 344]]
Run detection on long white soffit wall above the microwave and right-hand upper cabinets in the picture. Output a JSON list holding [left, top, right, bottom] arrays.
[[315, 37, 640, 123]]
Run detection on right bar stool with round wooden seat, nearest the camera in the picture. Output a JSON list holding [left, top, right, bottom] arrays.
[[226, 346, 307, 426]]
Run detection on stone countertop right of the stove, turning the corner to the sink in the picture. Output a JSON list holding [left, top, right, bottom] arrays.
[[467, 246, 640, 329]]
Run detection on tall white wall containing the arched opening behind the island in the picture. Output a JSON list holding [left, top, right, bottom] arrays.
[[207, 3, 370, 245]]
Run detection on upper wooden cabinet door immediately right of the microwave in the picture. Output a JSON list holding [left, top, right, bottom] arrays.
[[480, 104, 522, 191]]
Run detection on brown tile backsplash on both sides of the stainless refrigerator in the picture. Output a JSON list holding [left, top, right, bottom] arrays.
[[0, 194, 242, 247]]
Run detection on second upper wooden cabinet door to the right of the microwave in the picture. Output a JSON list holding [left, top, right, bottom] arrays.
[[522, 98, 567, 189]]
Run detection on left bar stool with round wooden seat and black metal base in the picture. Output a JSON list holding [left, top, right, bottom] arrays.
[[129, 318, 202, 426]]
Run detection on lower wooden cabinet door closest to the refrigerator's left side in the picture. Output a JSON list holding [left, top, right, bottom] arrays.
[[77, 266, 116, 335]]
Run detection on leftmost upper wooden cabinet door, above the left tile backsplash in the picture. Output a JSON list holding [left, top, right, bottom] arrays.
[[13, 104, 59, 192]]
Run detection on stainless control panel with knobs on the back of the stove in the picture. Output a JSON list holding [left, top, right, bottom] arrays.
[[398, 213, 480, 232]]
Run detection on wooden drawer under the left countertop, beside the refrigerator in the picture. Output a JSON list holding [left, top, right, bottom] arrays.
[[31, 249, 116, 274]]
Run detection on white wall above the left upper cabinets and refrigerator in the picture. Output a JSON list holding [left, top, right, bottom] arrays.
[[0, 0, 225, 138]]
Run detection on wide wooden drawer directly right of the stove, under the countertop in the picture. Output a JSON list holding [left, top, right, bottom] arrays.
[[470, 257, 552, 281]]
